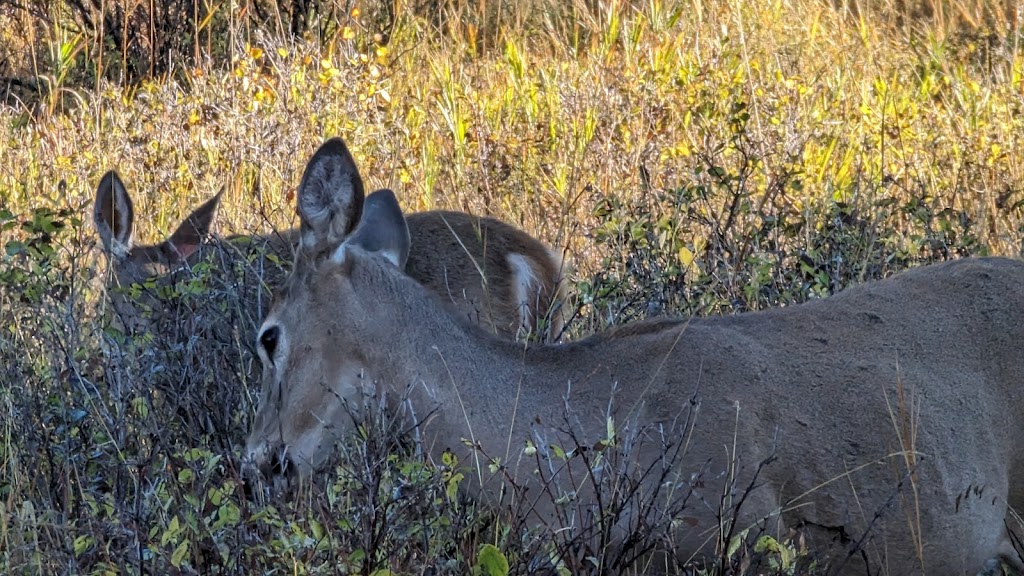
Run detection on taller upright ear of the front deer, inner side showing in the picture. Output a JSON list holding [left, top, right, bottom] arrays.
[[298, 137, 364, 250]]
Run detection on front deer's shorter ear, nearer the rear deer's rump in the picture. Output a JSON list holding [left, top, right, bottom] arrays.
[[332, 190, 412, 270]]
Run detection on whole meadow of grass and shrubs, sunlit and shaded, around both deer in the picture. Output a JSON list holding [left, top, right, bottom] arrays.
[[0, 0, 1024, 575]]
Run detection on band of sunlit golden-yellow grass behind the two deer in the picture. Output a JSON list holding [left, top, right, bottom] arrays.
[[0, 2, 1022, 264]]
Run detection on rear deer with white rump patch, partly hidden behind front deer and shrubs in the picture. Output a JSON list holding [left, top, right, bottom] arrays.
[[93, 141, 567, 446]]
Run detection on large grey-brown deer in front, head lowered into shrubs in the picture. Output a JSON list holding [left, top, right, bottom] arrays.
[[244, 135, 1024, 576]]
